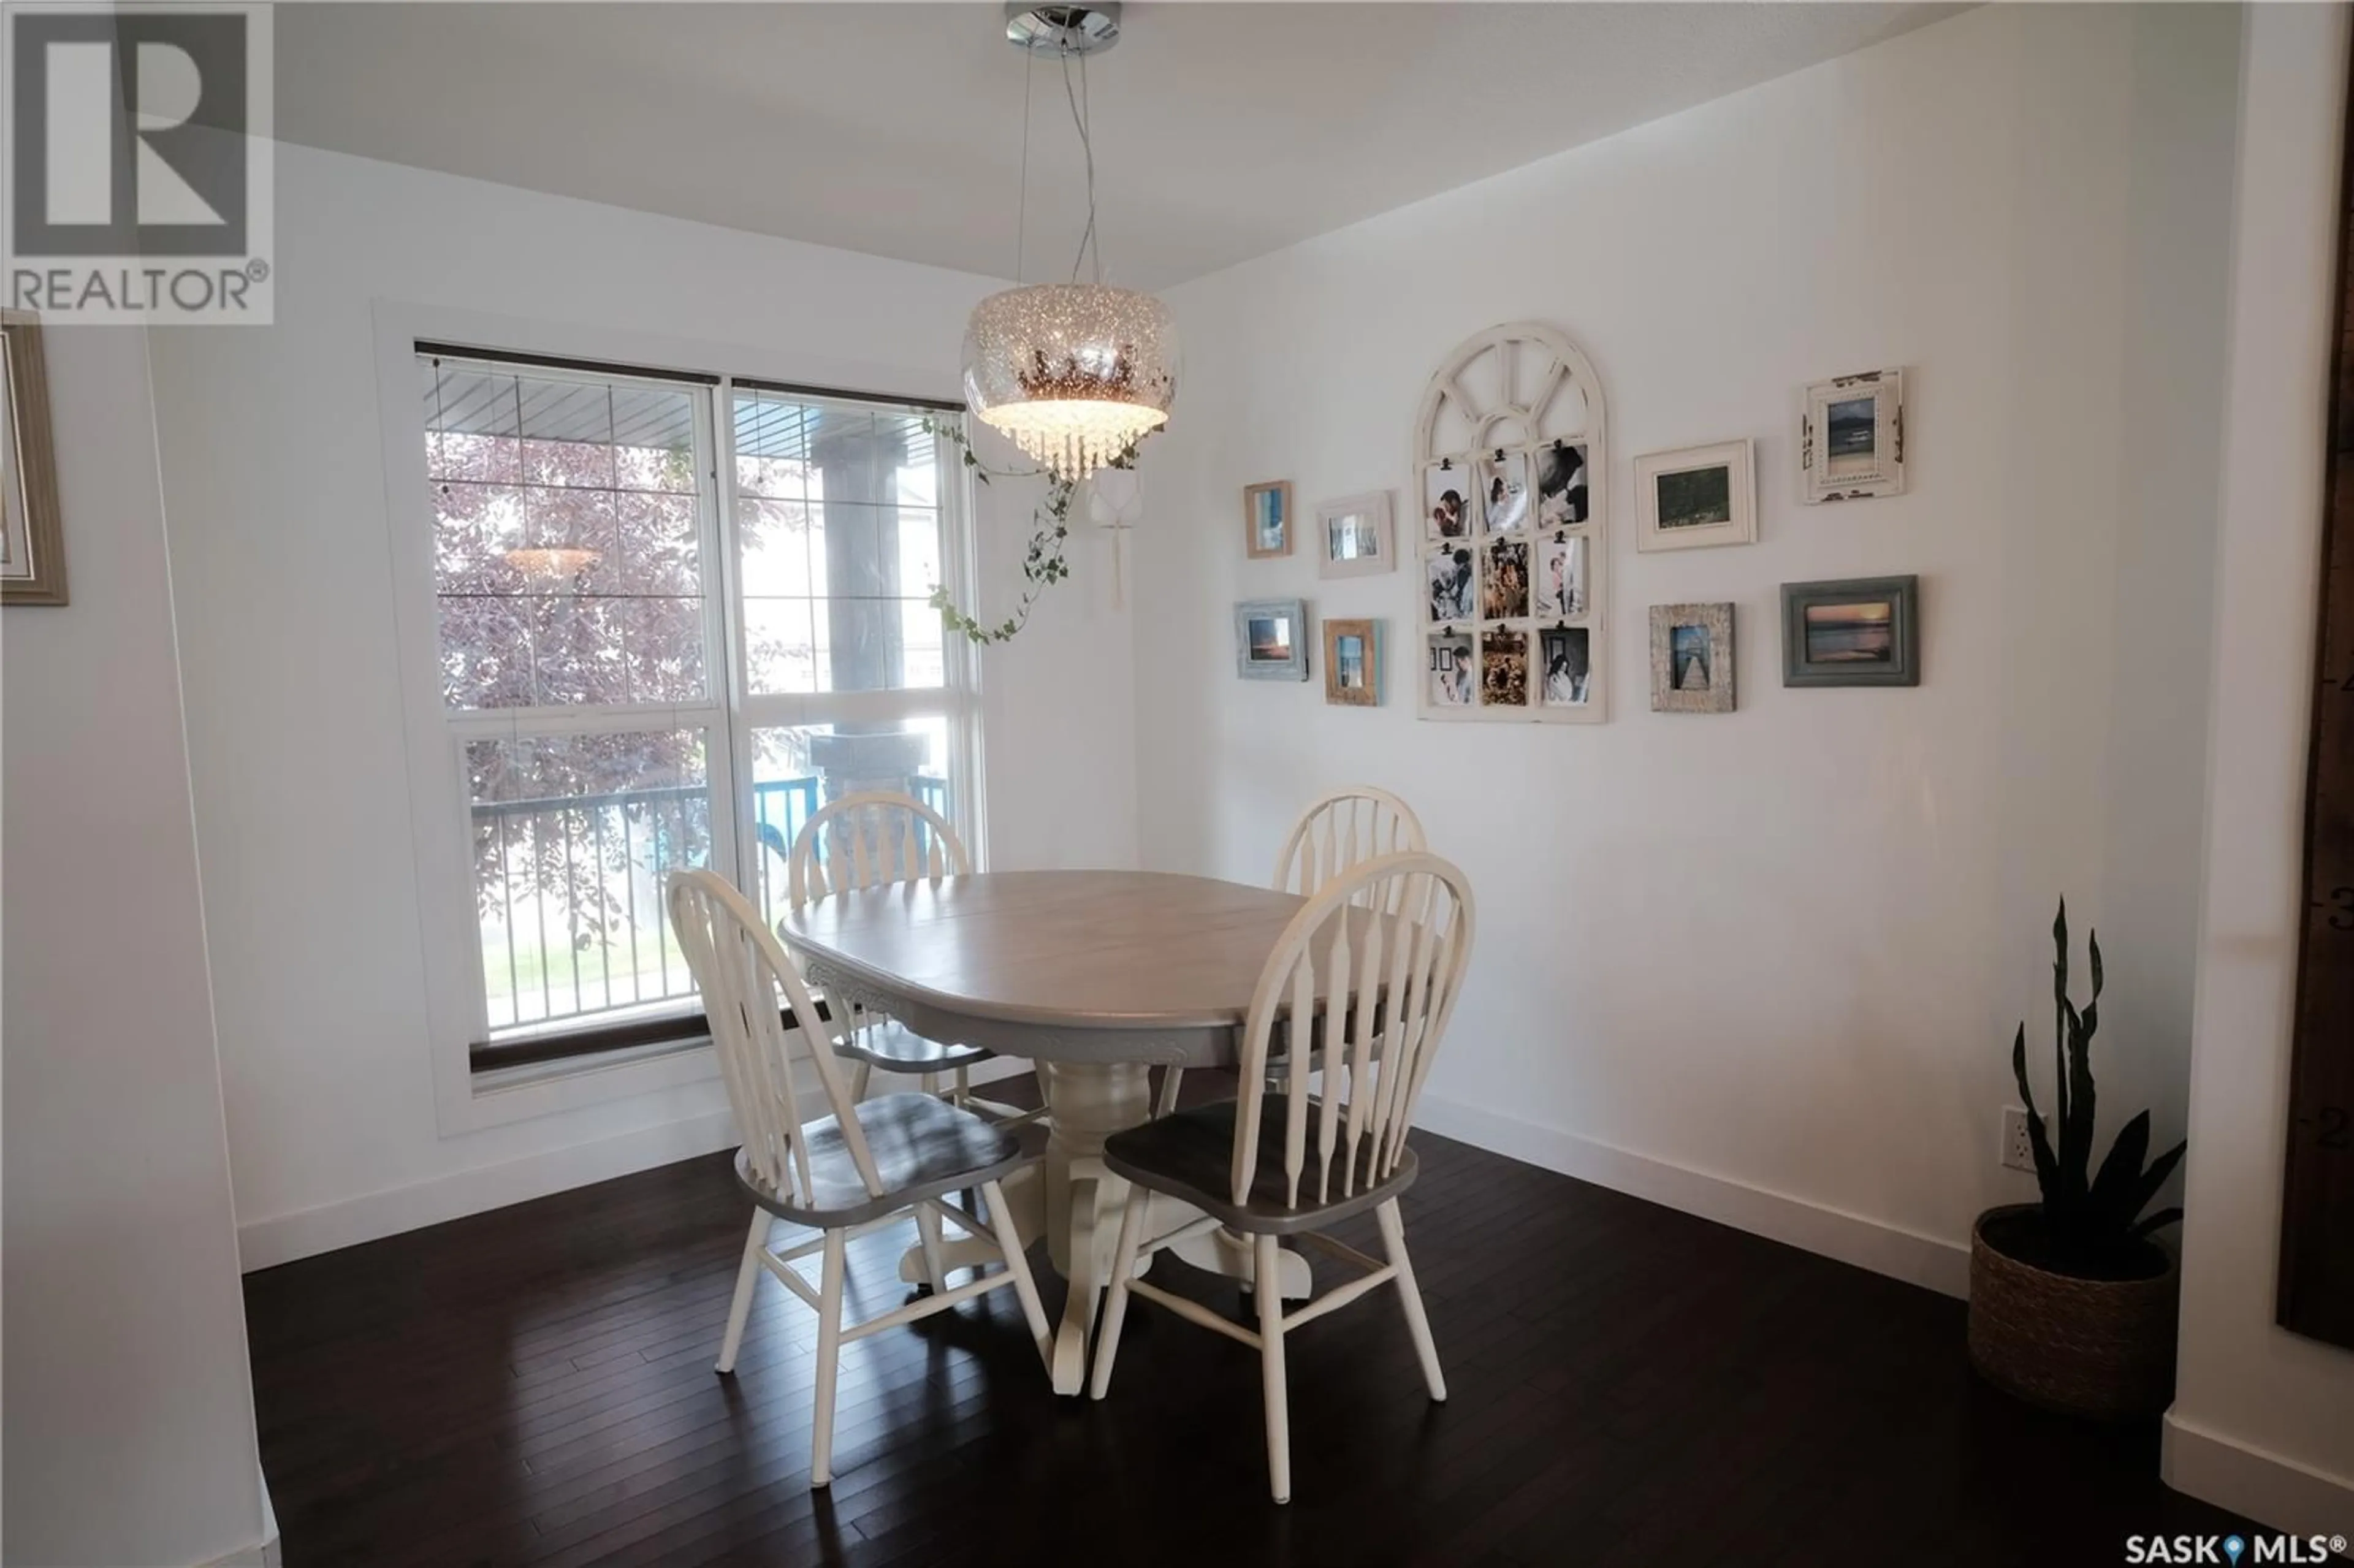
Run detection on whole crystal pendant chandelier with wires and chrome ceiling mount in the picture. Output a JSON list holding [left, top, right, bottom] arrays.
[[965, 0, 1177, 482]]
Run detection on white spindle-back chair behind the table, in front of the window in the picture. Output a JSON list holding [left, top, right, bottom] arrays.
[[787, 789, 1038, 1123]]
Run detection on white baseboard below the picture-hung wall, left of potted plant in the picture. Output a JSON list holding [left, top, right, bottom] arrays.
[[1415, 1095, 1970, 1297]]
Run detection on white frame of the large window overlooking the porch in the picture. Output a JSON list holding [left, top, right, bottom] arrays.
[[375, 302, 986, 1135]]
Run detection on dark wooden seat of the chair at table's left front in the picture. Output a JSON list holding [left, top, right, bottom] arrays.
[[737, 1095, 1045, 1229]]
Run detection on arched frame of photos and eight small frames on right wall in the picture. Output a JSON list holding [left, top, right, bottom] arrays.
[[1236, 322, 1921, 723]]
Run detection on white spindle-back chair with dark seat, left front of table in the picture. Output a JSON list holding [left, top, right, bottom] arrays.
[[666, 871, 1052, 1488]]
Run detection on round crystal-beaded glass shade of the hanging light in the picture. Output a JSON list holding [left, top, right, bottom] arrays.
[[965, 283, 1177, 481]]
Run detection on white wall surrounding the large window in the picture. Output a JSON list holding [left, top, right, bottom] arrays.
[[155, 146, 1135, 1266]]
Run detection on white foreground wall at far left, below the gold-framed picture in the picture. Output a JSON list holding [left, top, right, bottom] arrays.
[[0, 327, 261, 1568]]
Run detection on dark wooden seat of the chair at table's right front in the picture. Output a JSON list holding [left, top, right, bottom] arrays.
[[1104, 1095, 1415, 1236]]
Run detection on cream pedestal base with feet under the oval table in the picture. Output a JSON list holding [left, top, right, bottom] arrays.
[[899, 1062, 1309, 1396]]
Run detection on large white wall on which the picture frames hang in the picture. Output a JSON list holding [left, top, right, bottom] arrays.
[[1135, 7, 2236, 1290]]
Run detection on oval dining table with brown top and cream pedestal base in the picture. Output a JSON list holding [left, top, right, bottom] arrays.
[[777, 871, 1309, 1394]]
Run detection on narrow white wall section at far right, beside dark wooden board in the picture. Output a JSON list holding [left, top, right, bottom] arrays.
[[2166, 5, 2354, 1535]]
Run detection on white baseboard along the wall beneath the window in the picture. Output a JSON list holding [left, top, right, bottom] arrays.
[[238, 1059, 1049, 1274]]
